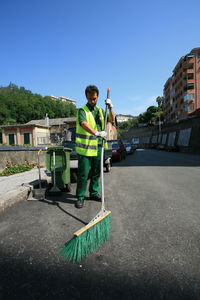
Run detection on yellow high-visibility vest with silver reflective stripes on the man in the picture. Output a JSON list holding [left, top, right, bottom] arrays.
[[76, 105, 108, 156]]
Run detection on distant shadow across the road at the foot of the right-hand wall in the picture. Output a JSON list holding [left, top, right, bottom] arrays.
[[112, 149, 200, 167]]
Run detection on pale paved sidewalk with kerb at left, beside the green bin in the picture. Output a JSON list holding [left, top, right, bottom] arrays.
[[0, 168, 50, 211]]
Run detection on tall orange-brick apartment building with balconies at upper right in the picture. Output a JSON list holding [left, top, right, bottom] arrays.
[[163, 48, 200, 123]]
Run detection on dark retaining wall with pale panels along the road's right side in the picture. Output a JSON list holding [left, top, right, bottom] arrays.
[[122, 117, 200, 153]]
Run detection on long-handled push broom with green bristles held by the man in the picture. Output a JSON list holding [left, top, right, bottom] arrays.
[[60, 88, 111, 263]]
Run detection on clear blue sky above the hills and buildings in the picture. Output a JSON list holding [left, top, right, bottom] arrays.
[[0, 0, 200, 115]]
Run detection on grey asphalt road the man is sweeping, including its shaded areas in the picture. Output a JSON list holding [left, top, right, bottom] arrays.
[[0, 150, 200, 300]]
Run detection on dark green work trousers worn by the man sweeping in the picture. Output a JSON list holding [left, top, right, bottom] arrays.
[[76, 146, 102, 199]]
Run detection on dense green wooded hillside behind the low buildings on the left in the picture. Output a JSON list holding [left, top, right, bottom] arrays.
[[0, 83, 76, 125]]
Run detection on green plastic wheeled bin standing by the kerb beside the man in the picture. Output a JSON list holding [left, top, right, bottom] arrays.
[[46, 146, 72, 191]]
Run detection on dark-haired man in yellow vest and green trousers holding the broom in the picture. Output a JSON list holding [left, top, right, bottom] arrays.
[[75, 85, 114, 208]]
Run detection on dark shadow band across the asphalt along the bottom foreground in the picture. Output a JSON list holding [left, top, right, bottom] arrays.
[[0, 255, 199, 300]]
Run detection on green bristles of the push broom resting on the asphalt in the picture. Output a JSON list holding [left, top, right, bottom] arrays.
[[60, 214, 111, 263]]
